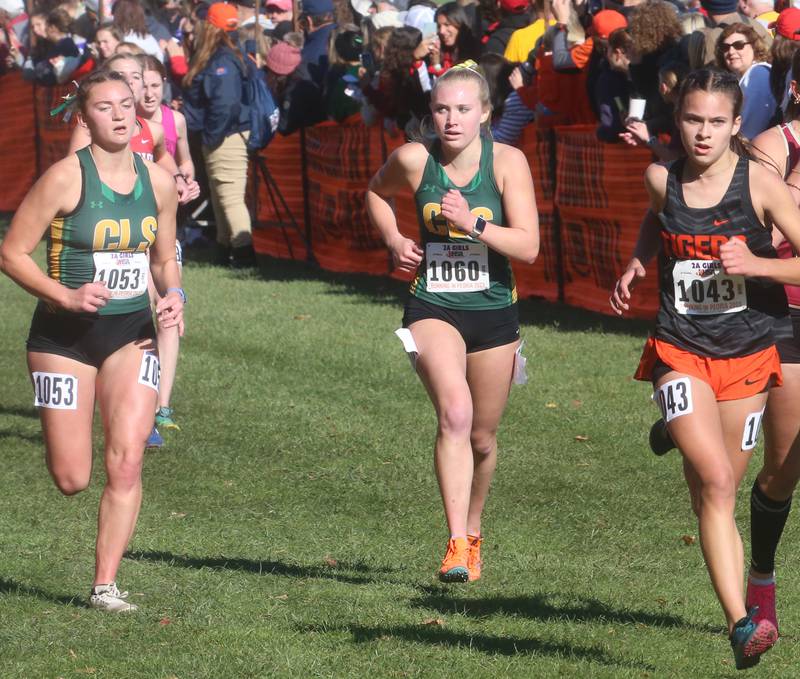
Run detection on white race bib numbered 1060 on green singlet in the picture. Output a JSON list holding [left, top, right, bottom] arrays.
[[425, 243, 489, 292]]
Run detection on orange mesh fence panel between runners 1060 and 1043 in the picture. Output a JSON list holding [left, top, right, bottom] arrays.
[[556, 126, 658, 318]]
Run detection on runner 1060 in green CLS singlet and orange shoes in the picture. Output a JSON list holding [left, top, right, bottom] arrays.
[[367, 62, 539, 582]]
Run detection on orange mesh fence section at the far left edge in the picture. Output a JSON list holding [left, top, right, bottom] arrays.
[[0, 72, 36, 212]]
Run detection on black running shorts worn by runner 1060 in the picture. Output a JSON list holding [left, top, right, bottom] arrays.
[[403, 295, 519, 354]]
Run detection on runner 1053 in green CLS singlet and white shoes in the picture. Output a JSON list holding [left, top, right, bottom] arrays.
[[0, 72, 184, 611]]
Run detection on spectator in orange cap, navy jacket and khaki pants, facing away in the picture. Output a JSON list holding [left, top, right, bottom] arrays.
[[183, 2, 255, 266]]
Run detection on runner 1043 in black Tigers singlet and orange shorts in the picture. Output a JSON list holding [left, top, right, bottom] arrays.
[[610, 70, 800, 669]]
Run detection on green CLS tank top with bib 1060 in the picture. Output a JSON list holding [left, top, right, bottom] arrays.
[[410, 138, 517, 309]]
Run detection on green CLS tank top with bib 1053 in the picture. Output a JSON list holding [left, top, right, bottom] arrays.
[[47, 146, 158, 316]]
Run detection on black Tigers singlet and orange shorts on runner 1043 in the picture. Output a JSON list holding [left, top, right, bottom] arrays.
[[636, 151, 790, 401]]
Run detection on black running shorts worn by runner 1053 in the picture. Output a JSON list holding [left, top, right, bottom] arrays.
[[27, 304, 156, 369]]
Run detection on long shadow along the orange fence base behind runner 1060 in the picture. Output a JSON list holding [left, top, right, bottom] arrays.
[[189, 256, 652, 337]]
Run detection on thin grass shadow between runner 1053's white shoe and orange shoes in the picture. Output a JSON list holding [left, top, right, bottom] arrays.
[[125, 551, 394, 585]]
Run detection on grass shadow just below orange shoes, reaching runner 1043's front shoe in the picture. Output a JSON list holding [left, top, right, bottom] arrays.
[[410, 587, 722, 633]]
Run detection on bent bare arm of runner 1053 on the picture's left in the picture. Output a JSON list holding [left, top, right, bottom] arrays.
[[0, 155, 109, 312]]
